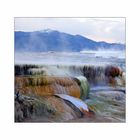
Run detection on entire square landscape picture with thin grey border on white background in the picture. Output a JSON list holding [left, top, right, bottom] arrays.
[[14, 17, 126, 123]]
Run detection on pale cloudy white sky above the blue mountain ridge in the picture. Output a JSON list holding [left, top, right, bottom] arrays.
[[15, 18, 125, 43]]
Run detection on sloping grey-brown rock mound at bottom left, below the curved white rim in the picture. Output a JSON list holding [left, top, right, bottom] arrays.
[[15, 94, 82, 122]]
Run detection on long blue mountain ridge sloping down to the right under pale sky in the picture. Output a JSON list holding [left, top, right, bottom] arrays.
[[15, 29, 125, 52]]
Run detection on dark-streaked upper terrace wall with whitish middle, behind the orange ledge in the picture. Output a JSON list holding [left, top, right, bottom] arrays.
[[15, 65, 125, 86]]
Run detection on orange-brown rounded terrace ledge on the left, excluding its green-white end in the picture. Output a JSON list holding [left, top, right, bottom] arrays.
[[15, 76, 81, 98]]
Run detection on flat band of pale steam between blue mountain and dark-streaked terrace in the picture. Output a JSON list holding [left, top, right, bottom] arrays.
[[15, 50, 125, 66]]
